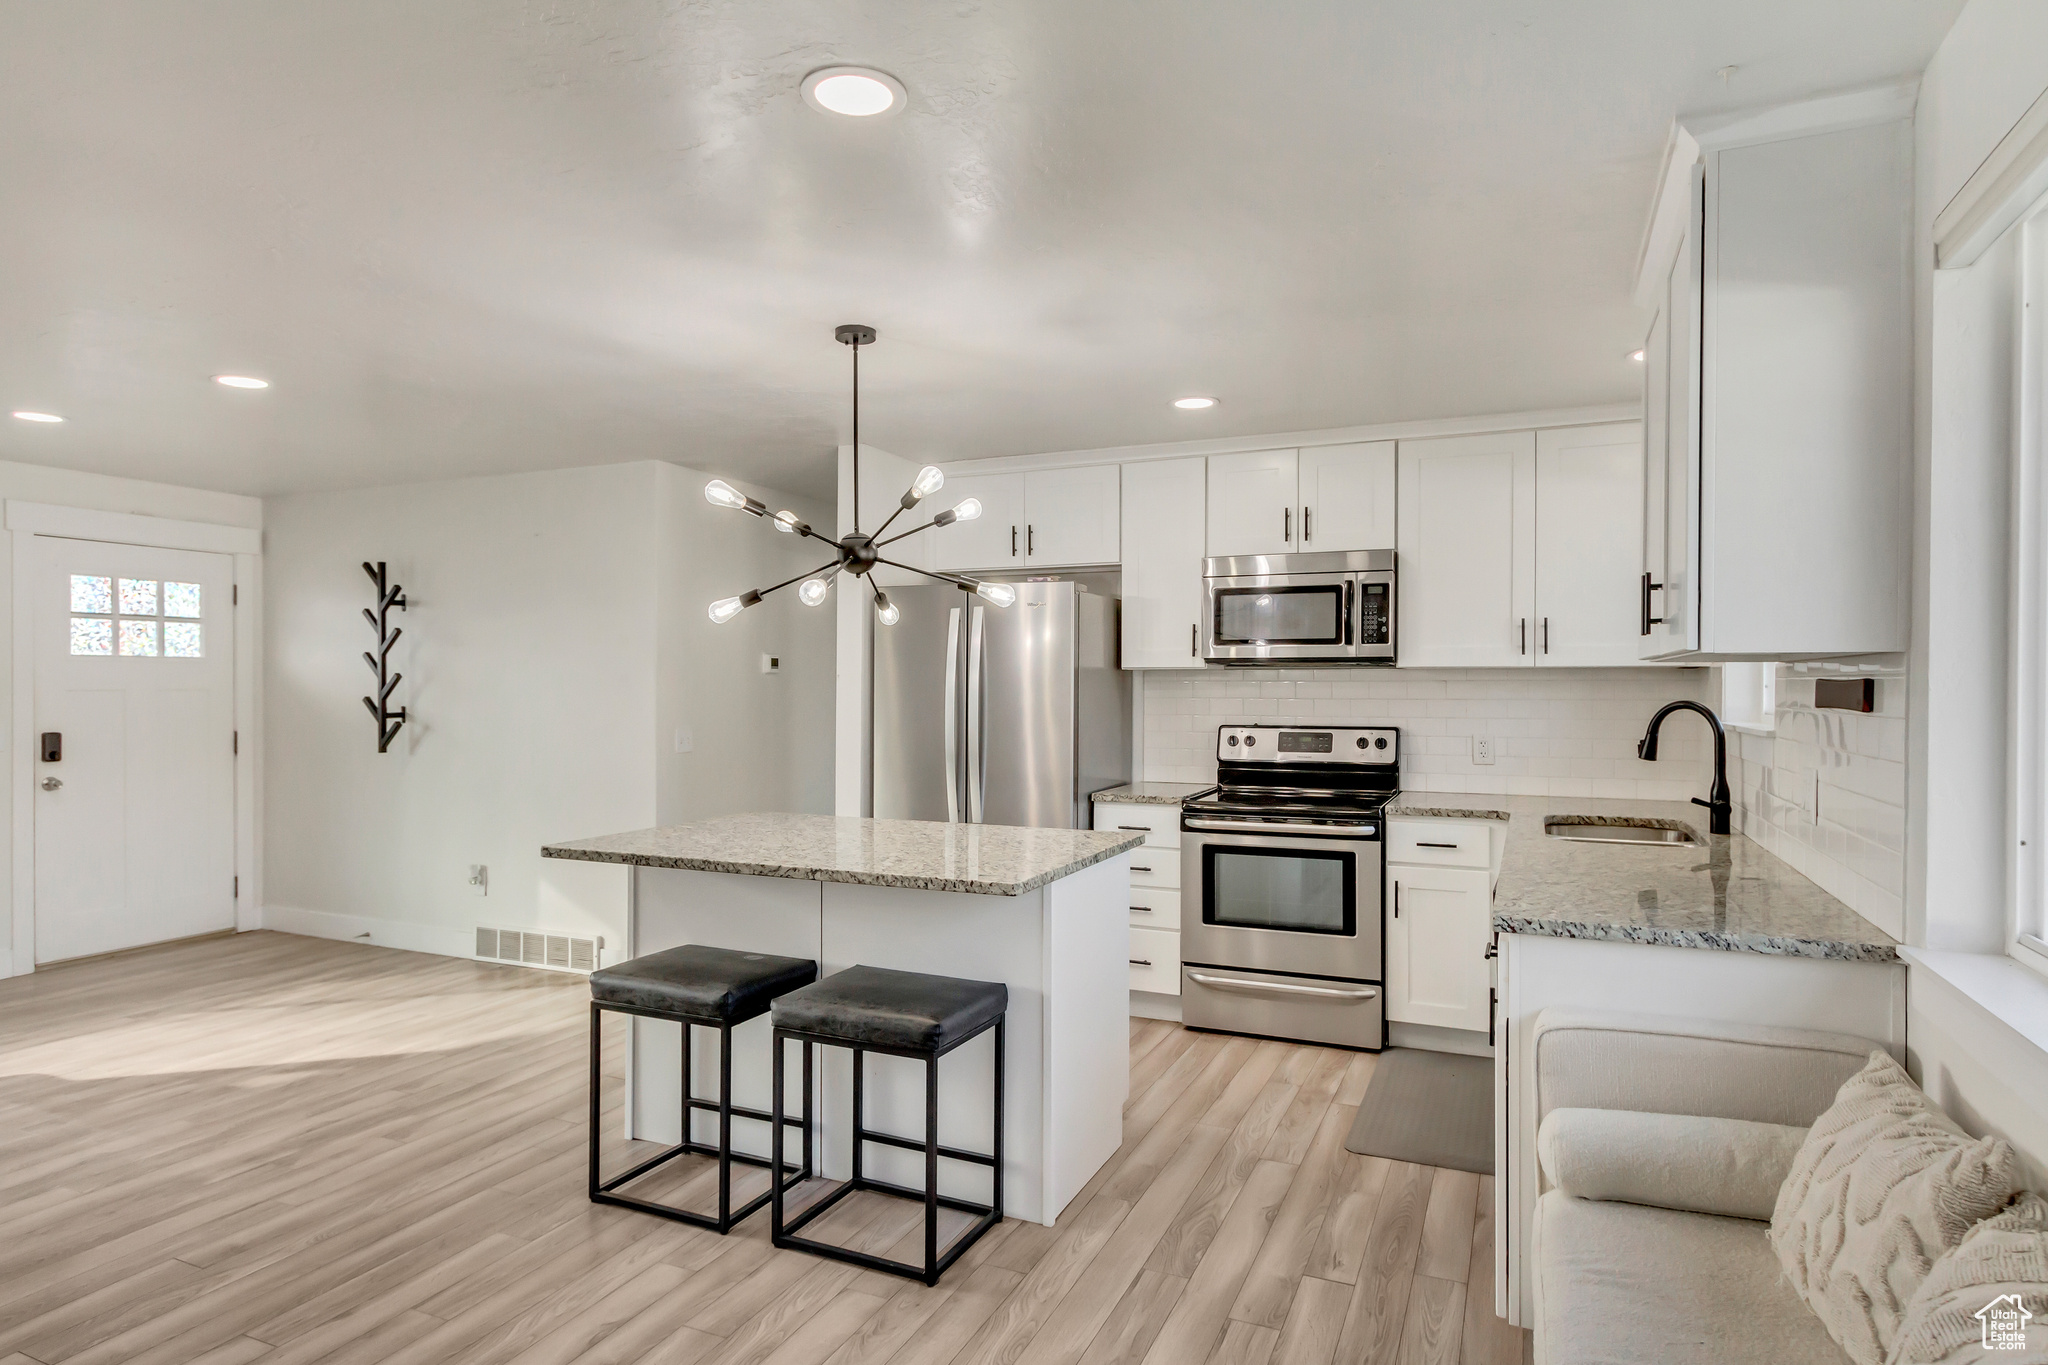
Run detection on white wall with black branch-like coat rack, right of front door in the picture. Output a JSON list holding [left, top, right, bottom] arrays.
[[264, 463, 829, 960]]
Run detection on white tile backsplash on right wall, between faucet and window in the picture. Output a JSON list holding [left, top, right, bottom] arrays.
[[1729, 655, 1907, 937]]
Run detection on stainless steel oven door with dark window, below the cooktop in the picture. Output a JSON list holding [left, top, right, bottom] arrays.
[[1180, 817, 1384, 982]]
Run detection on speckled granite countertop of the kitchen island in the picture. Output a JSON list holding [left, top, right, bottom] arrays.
[[541, 812, 1145, 896]]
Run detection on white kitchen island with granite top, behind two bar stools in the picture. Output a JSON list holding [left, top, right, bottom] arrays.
[[541, 812, 1143, 1224]]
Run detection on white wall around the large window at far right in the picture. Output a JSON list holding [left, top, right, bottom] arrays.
[[1905, 0, 2048, 1175]]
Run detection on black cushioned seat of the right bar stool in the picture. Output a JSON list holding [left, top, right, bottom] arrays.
[[774, 966, 1010, 1052]]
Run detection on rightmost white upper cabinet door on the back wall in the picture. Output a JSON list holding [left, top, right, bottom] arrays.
[[1532, 422, 1642, 667]]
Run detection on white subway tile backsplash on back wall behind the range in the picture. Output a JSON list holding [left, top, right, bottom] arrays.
[[1141, 667, 1718, 800]]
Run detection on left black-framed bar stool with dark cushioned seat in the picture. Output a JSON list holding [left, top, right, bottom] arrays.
[[590, 943, 817, 1234]]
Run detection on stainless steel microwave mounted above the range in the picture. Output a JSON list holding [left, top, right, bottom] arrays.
[[1202, 551, 1397, 663]]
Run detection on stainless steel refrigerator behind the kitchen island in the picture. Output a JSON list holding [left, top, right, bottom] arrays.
[[874, 581, 1130, 829]]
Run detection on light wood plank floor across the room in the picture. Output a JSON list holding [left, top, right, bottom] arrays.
[[0, 933, 1526, 1365]]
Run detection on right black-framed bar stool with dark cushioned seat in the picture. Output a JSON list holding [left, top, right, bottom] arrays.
[[770, 966, 1010, 1285]]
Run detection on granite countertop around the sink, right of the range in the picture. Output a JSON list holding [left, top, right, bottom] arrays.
[[1389, 792, 1898, 962]]
